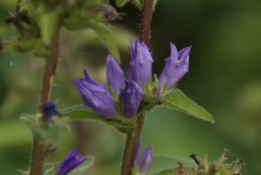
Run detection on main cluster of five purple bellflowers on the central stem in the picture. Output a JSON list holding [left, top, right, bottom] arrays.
[[73, 40, 191, 118]]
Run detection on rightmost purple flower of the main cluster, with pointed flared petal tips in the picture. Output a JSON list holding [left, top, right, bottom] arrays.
[[158, 43, 191, 89]]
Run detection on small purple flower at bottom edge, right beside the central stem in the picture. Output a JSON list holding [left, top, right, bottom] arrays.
[[135, 140, 153, 174]]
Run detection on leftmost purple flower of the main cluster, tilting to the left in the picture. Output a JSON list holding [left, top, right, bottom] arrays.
[[72, 70, 117, 117]]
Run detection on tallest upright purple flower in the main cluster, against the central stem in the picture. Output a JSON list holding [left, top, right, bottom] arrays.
[[127, 40, 153, 87]]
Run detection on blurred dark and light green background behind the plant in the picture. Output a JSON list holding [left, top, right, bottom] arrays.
[[0, 0, 261, 175]]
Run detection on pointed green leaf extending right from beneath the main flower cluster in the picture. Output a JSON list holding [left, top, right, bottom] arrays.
[[162, 89, 215, 123]]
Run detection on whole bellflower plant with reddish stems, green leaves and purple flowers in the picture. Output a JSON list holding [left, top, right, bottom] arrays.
[[0, 0, 243, 175]]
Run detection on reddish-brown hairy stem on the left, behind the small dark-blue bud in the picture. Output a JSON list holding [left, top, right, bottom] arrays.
[[30, 26, 60, 175]]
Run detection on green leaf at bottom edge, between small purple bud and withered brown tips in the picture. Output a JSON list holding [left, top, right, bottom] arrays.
[[148, 155, 193, 175]]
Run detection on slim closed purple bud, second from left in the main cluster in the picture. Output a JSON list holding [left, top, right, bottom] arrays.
[[106, 55, 125, 95]]
